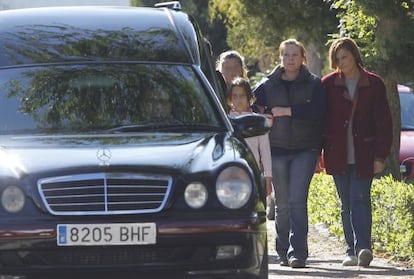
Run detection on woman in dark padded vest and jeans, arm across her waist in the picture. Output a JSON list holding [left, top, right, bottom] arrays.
[[254, 39, 326, 268]]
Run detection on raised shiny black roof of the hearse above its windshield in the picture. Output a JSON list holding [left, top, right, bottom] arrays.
[[0, 6, 200, 67]]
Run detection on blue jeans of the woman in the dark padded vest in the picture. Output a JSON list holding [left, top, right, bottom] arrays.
[[272, 150, 319, 260]]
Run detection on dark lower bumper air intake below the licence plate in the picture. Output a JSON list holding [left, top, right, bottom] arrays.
[[0, 244, 216, 270]]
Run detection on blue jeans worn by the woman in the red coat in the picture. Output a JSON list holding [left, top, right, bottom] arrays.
[[333, 165, 372, 255]]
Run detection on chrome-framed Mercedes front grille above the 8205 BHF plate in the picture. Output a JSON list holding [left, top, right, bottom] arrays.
[[38, 173, 172, 215]]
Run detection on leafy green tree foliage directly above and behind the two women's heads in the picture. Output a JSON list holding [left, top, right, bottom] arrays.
[[209, 0, 338, 72]]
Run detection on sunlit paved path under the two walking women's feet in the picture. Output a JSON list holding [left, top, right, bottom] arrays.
[[267, 221, 414, 279]]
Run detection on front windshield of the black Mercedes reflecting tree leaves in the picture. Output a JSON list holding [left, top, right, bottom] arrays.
[[0, 63, 223, 134]]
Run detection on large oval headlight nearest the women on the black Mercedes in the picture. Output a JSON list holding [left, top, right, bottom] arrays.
[[216, 166, 253, 209]]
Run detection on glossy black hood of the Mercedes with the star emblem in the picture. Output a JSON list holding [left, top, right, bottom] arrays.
[[0, 133, 234, 175]]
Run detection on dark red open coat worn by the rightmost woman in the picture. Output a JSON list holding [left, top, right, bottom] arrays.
[[322, 70, 392, 178]]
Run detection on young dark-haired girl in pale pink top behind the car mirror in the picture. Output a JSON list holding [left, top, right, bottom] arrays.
[[227, 77, 272, 196]]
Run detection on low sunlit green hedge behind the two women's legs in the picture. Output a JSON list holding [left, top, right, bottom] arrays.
[[308, 173, 414, 267]]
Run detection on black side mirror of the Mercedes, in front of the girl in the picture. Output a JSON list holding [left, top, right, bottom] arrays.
[[229, 113, 271, 138]]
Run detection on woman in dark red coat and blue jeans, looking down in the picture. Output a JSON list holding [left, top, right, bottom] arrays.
[[322, 38, 392, 266]]
